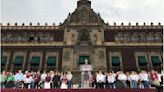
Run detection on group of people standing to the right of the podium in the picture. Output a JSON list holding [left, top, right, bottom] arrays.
[[91, 70, 163, 89]]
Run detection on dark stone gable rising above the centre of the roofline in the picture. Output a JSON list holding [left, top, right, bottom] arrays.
[[65, 0, 104, 24]]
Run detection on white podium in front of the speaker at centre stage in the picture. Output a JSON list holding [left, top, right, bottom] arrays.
[[80, 64, 93, 88]]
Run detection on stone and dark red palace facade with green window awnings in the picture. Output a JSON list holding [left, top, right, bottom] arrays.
[[1, 0, 163, 76]]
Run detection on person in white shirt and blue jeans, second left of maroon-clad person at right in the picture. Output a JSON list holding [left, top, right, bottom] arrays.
[[129, 71, 139, 88]]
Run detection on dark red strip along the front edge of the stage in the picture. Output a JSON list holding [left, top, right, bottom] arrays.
[[1, 89, 158, 92]]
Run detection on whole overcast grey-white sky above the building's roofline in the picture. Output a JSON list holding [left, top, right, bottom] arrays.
[[1, 0, 164, 25]]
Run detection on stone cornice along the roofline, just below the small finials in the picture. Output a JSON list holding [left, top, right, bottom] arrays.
[[1, 23, 163, 30]]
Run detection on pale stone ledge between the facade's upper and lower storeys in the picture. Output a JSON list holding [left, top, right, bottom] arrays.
[[1, 42, 163, 47]]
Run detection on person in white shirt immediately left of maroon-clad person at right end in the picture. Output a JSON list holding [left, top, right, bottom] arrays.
[[139, 71, 149, 88]]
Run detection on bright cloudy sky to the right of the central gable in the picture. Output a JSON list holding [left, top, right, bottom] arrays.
[[93, 0, 163, 24]]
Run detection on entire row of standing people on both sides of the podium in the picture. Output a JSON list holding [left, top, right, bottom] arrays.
[[0, 70, 163, 89]]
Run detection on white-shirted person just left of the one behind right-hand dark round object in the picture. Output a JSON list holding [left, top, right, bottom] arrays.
[[107, 72, 116, 88]]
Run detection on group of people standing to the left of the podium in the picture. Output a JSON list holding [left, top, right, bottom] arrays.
[[0, 70, 73, 89]]
